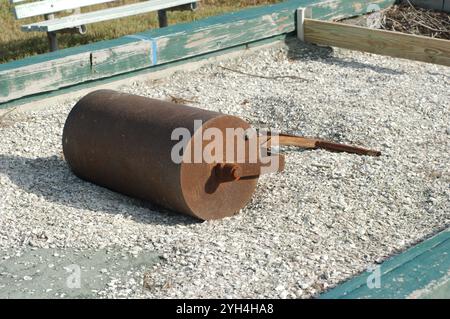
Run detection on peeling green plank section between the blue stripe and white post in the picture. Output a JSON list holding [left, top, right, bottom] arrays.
[[148, 1, 302, 63]]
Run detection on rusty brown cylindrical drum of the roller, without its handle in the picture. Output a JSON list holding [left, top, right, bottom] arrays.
[[63, 90, 257, 220]]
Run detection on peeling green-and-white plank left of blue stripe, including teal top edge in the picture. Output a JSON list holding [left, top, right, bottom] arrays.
[[0, 38, 153, 103]]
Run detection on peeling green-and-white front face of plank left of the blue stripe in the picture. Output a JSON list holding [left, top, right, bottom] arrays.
[[0, 39, 153, 102]]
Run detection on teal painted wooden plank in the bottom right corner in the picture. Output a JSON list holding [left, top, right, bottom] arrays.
[[319, 229, 450, 299]]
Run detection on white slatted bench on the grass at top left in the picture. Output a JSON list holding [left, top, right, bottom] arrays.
[[10, 0, 198, 51]]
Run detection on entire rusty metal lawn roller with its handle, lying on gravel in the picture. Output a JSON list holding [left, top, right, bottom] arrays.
[[63, 90, 380, 220]]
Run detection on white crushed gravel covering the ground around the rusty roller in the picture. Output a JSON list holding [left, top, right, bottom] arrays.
[[0, 40, 450, 298]]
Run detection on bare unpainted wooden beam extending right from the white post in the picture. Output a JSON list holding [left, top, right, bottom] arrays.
[[304, 19, 450, 66]]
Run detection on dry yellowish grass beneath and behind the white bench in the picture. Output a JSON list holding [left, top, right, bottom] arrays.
[[0, 0, 279, 63]]
